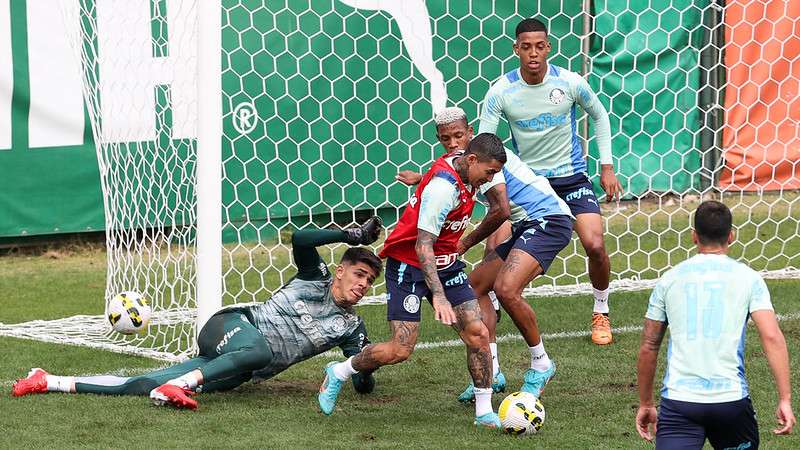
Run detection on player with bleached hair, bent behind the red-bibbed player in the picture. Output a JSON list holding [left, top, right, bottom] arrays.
[[398, 107, 574, 402]]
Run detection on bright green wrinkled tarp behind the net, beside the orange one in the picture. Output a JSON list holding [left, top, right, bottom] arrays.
[[589, 0, 708, 196]]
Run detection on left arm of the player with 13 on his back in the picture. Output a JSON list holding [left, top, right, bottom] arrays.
[[636, 319, 667, 441]]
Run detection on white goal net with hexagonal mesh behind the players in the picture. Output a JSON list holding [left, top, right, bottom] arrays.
[[0, 0, 800, 359]]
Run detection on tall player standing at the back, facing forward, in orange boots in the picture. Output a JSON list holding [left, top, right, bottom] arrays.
[[478, 19, 622, 345]]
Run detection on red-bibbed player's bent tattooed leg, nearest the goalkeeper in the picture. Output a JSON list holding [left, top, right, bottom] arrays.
[[352, 320, 422, 375]]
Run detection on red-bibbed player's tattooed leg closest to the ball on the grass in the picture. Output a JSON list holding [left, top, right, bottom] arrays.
[[453, 300, 492, 388]]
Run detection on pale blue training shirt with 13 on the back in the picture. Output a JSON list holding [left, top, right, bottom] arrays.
[[645, 254, 772, 403]]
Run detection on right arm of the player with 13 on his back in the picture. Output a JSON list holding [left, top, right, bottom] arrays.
[[750, 309, 796, 434]]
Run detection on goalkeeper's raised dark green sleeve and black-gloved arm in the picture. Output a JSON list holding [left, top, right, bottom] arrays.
[[292, 216, 383, 280]]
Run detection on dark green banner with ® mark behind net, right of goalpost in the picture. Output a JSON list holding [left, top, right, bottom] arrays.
[[222, 0, 581, 243]]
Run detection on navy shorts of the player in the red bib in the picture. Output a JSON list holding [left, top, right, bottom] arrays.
[[386, 258, 478, 322]]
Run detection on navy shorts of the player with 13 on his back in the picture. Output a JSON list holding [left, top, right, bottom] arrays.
[[656, 397, 759, 450]]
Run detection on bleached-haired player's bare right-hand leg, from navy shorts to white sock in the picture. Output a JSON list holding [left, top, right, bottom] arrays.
[[494, 248, 542, 347]]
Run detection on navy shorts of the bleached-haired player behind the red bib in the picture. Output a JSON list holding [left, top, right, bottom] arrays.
[[494, 215, 572, 272]]
